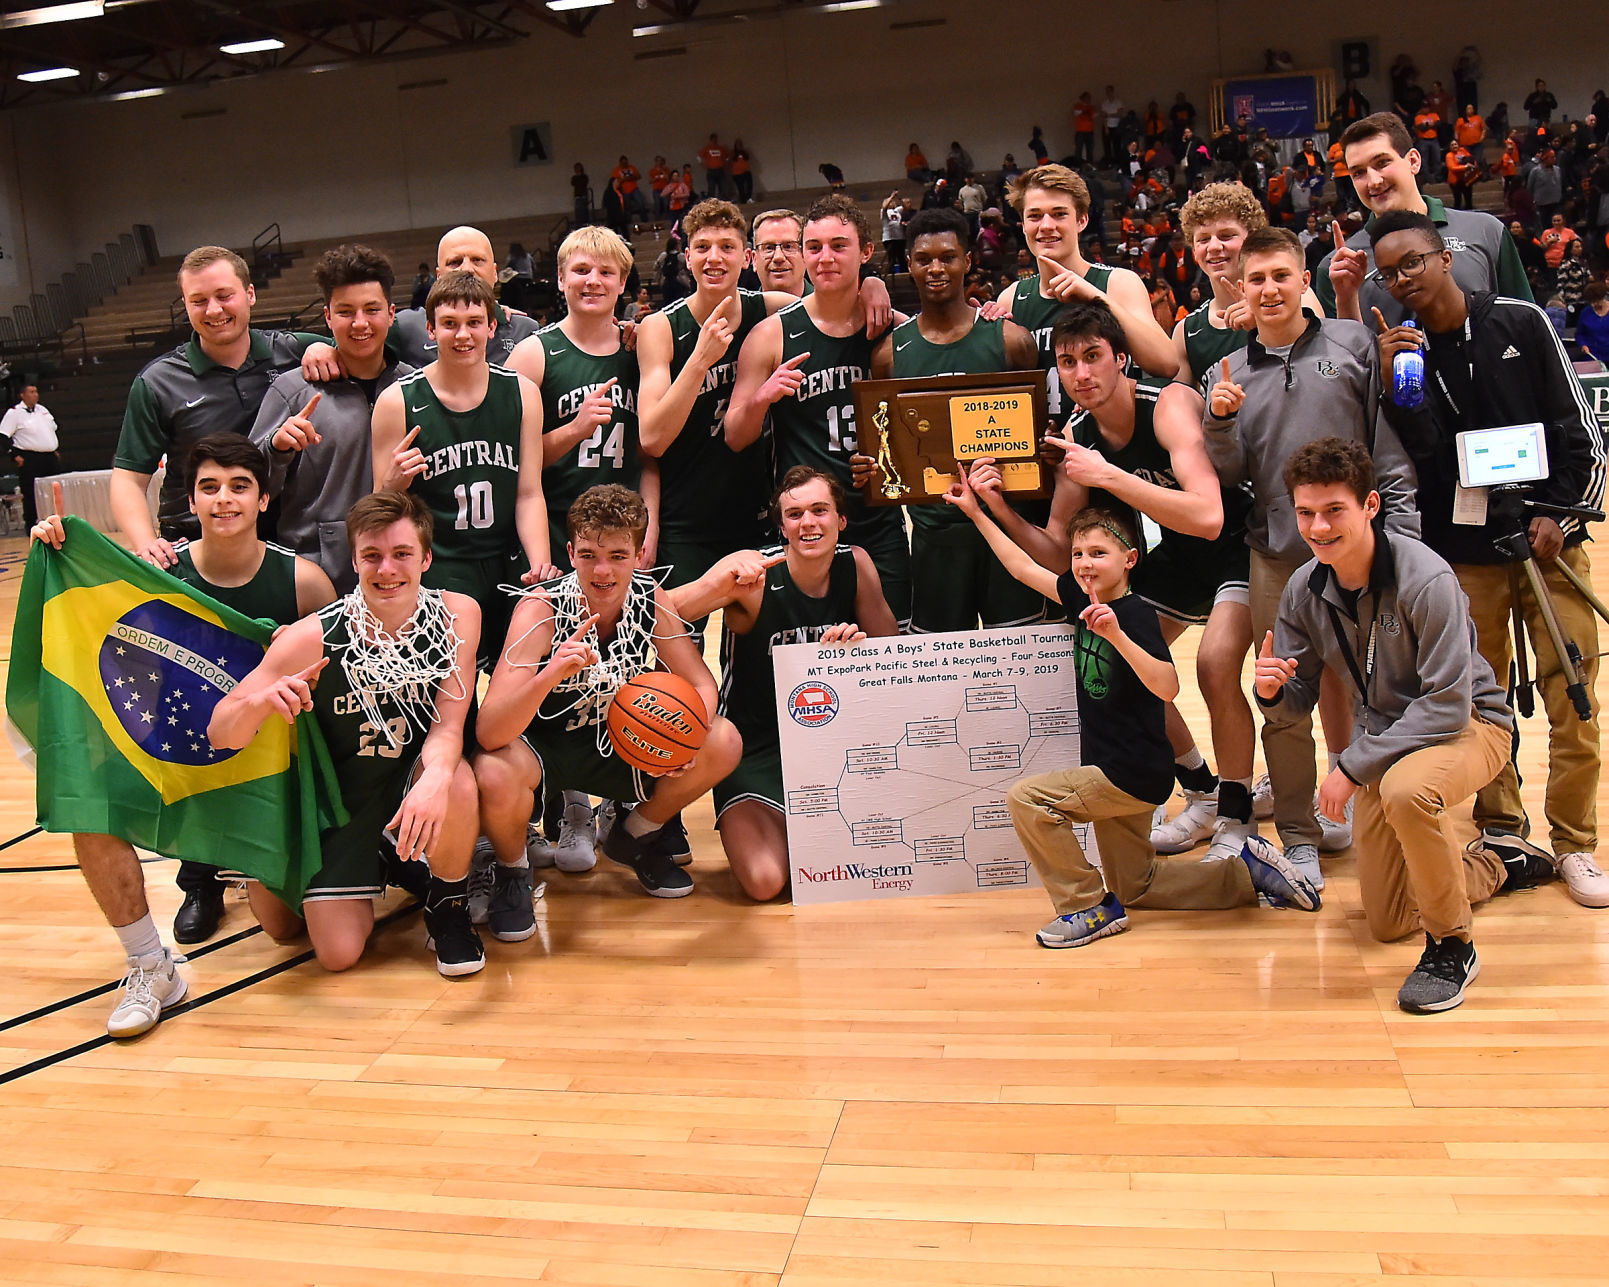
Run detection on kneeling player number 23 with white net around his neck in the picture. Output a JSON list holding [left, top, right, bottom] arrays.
[[208, 491, 485, 978]]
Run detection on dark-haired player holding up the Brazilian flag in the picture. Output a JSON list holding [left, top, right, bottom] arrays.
[[31, 444, 335, 1036]]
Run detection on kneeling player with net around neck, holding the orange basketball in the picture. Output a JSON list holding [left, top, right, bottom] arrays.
[[475, 484, 742, 909]]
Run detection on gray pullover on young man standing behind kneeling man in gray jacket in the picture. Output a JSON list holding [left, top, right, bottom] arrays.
[[1202, 312, 1419, 563]]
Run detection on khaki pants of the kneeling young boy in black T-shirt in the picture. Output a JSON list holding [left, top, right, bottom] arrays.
[[1006, 764, 1257, 915]]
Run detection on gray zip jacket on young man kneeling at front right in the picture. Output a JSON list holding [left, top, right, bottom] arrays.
[[1257, 524, 1514, 785]]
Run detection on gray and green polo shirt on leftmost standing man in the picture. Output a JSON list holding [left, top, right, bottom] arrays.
[[113, 330, 323, 541]]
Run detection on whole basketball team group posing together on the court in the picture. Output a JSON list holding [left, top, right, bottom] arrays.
[[22, 114, 1609, 1036]]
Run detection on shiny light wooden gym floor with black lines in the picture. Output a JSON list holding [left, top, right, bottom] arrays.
[[0, 527, 1609, 1287]]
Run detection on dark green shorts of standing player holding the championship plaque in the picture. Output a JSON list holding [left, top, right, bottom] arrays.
[[911, 523, 1044, 634]]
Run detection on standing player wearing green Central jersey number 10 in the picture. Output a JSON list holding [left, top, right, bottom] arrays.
[[373, 272, 553, 668]]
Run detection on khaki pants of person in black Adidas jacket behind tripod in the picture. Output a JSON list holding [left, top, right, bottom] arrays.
[[1453, 545, 1599, 854]]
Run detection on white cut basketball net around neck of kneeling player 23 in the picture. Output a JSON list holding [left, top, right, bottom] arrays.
[[326, 589, 468, 748]]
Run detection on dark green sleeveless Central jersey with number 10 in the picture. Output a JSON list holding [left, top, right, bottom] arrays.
[[397, 367, 525, 560]]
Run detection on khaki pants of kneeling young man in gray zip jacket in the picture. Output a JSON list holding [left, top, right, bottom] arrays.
[[1352, 719, 1509, 943]]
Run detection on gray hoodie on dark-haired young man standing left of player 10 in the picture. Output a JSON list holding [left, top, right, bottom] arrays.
[[251, 362, 414, 594]]
